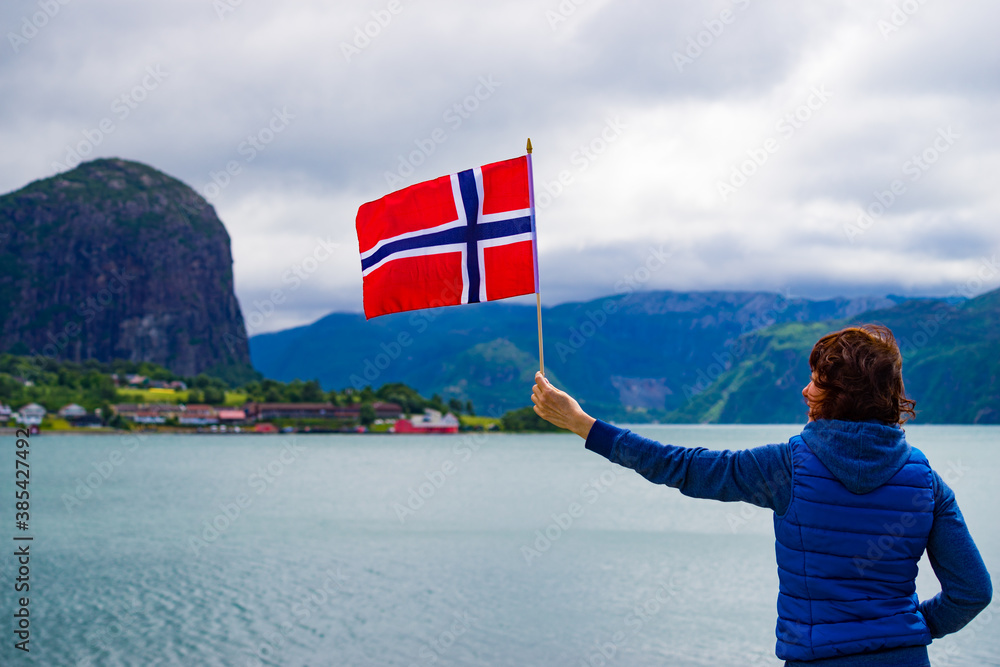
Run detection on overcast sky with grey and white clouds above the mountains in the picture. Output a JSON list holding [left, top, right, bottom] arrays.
[[0, 0, 1000, 333]]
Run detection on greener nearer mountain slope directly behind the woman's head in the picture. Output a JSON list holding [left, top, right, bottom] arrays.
[[669, 290, 1000, 424]]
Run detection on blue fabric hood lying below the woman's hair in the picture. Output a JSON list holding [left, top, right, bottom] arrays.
[[801, 419, 910, 494]]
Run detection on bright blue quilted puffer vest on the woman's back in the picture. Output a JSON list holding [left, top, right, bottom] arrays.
[[774, 436, 934, 661]]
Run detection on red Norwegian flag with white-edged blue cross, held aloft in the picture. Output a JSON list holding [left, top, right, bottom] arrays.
[[357, 155, 538, 319]]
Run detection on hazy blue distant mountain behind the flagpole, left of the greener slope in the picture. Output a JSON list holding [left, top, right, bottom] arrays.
[[250, 292, 895, 420]]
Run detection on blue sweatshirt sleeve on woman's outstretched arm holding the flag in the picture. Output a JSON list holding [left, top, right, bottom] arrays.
[[586, 420, 792, 514]]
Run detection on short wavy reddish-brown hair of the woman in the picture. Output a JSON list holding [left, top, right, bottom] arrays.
[[809, 324, 916, 424]]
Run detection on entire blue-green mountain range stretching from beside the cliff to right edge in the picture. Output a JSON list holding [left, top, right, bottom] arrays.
[[250, 291, 1000, 423]]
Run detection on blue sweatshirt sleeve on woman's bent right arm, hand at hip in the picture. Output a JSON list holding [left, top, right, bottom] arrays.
[[920, 471, 993, 639]]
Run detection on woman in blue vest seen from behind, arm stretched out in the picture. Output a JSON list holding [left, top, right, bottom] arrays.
[[532, 325, 993, 667]]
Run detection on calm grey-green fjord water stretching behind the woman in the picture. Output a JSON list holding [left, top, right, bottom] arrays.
[[0, 426, 1000, 667]]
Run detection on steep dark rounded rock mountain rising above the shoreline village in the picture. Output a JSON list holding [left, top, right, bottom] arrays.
[[0, 160, 252, 378]]
